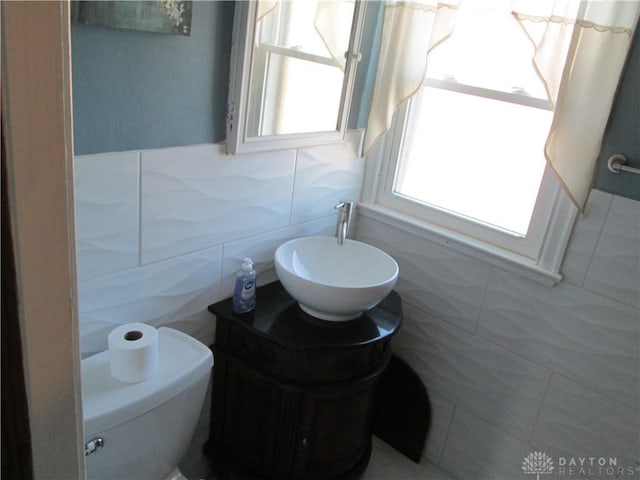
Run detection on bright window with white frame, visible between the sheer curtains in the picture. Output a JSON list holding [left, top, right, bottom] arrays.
[[365, 2, 576, 282]]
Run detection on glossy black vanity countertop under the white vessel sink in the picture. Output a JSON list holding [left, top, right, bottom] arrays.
[[208, 282, 402, 350]]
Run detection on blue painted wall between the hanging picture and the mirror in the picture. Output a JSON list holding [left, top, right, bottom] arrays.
[[71, 1, 234, 154]]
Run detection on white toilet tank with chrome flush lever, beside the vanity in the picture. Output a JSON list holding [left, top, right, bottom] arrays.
[[82, 327, 213, 480]]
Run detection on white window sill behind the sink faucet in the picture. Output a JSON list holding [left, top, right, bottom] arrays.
[[358, 203, 562, 286]]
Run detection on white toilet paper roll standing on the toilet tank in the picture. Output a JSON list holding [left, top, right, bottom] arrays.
[[108, 323, 158, 383]]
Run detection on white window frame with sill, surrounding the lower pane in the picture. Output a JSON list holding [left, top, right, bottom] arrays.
[[359, 86, 578, 285]]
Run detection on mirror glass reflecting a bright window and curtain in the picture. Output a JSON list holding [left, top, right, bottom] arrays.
[[250, 1, 355, 135]]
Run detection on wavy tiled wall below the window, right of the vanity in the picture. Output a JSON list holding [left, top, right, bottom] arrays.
[[357, 191, 640, 480]]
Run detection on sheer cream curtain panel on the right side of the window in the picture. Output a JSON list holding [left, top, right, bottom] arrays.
[[514, 0, 640, 209]]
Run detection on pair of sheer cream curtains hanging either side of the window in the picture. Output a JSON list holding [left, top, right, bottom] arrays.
[[364, 0, 640, 208]]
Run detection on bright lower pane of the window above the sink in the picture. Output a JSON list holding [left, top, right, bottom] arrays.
[[394, 87, 553, 236]]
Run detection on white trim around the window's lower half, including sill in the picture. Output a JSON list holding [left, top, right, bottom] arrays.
[[358, 98, 578, 286]]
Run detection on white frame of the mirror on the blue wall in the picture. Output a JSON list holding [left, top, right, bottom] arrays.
[[226, 0, 366, 155]]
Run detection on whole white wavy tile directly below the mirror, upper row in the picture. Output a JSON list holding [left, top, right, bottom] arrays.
[[141, 145, 296, 263]]
